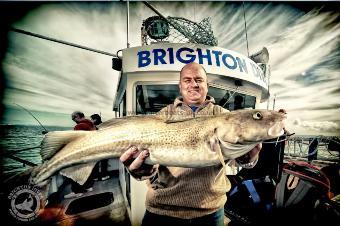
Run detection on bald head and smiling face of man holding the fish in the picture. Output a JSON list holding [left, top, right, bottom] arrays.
[[179, 64, 208, 105]]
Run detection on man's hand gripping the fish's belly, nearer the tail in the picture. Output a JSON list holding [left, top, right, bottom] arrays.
[[119, 146, 153, 177]]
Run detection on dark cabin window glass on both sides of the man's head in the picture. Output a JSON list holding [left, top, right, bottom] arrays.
[[136, 84, 256, 114]]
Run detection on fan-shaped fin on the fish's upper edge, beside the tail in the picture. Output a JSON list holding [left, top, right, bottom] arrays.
[[40, 130, 89, 161]]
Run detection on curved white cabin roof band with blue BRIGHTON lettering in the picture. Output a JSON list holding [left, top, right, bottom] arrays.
[[114, 42, 269, 109]]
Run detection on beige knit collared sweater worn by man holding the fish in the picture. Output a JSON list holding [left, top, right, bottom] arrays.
[[142, 96, 230, 219]]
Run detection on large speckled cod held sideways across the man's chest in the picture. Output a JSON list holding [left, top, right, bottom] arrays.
[[31, 109, 286, 184]]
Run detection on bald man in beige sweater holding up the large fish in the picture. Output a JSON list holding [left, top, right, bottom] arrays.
[[120, 63, 261, 226]]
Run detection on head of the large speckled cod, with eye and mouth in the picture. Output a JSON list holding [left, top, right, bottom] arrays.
[[217, 109, 286, 144]]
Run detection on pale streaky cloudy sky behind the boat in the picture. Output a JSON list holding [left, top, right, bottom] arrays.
[[0, 1, 340, 136]]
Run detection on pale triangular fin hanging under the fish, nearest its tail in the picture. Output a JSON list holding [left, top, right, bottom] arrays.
[[59, 162, 96, 185]]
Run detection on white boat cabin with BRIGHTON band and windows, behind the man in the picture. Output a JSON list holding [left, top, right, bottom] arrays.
[[113, 43, 269, 226]]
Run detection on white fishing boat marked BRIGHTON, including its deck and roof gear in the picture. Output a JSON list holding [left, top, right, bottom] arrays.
[[3, 2, 340, 226]]
